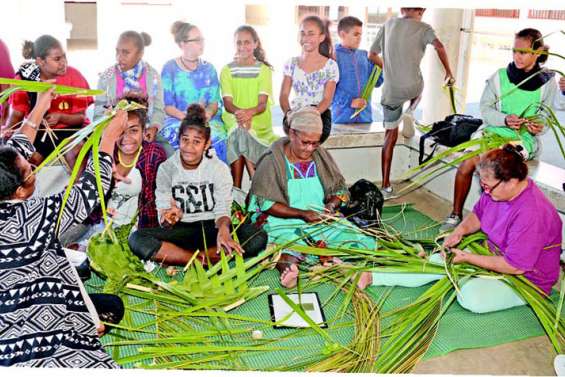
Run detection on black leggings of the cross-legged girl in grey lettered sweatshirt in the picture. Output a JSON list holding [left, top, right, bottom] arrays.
[[128, 220, 268, 260]]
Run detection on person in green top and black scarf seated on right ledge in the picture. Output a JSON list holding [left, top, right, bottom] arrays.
[[440, 29, 565, 232]]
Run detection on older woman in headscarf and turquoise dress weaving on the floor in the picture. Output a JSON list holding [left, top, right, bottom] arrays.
[[248, 107, 375, 288]]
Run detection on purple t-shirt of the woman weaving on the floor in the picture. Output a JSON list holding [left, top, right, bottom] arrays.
[[473, 178, 562, 294]]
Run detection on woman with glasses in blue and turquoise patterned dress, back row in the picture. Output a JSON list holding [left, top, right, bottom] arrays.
[[160, 21, 227, 162]]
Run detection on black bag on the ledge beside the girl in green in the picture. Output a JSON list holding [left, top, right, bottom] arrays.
[[418, 114, 483, 164]]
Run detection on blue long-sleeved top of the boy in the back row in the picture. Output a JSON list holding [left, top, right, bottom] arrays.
[[332, 44, 383, 123]]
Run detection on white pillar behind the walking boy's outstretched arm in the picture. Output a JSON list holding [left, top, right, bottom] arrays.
[[421, 9, 474, 124]]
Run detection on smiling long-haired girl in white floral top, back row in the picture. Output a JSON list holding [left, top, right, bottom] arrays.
[[279, 16, 339, 142]]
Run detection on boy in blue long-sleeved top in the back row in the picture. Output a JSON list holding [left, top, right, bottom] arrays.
[[332, 16, 383, 123]]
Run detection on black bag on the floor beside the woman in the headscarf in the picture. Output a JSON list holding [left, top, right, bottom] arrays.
[[340, 179, 384, 228]]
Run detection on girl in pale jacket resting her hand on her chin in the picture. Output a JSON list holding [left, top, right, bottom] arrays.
[[94, 30, 170, 156]]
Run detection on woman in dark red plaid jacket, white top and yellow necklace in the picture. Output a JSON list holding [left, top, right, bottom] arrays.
[[60, 95, 167, 249]]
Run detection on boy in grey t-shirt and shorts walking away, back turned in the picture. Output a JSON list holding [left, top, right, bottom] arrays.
[[370, 8, 454, 199]]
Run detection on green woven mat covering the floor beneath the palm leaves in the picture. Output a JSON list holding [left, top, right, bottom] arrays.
[[87, 207, 556, 370]]
